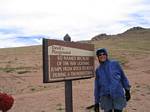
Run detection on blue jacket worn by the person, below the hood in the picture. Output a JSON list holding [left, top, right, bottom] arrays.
[[94, 60, 130, 103]]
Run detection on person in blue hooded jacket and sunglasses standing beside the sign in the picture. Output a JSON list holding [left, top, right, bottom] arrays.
[[94, 48, 131, 112]]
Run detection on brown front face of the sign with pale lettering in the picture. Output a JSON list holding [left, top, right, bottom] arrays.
[[42, 40, 94, 82]]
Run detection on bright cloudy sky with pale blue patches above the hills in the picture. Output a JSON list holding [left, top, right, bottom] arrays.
[[0, 0, 150, 48]]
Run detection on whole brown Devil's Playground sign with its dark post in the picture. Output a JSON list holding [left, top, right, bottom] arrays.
[[43, 35, 94, 112]]
